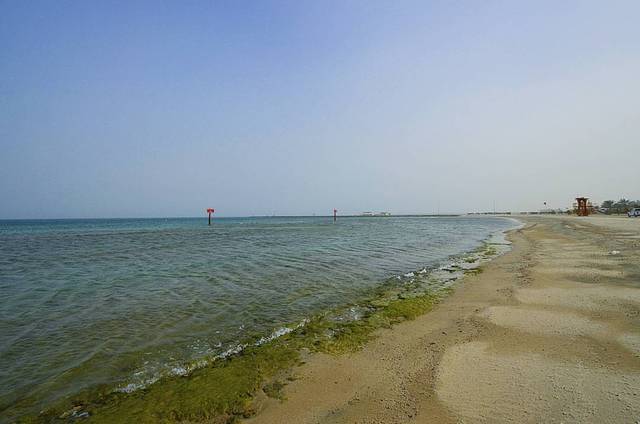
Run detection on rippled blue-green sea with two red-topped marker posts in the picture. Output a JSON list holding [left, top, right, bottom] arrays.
[[0, 217, 514, 418]]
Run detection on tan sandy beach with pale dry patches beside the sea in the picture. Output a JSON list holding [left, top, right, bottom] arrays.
[[247, 217, 640, 423]]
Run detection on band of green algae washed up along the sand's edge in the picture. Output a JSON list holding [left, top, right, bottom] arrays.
[[23, 290, 446, 423]]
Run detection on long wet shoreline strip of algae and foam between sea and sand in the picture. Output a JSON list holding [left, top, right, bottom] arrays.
[[15, 220, 509, 422]]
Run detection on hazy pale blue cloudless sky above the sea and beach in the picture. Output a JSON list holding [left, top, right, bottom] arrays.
[[0, 0, 640, 219]]
